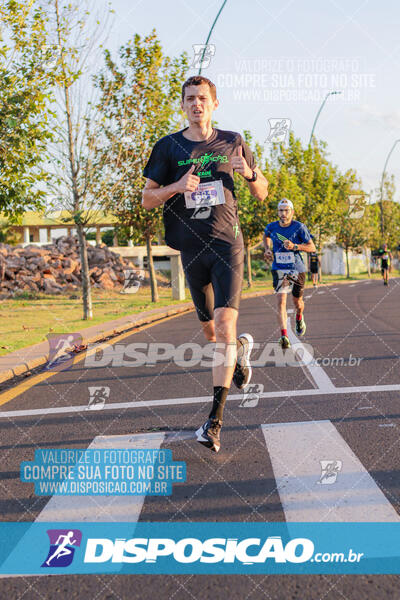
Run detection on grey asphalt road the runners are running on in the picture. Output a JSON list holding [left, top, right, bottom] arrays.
[[0, 279, 400, 600]]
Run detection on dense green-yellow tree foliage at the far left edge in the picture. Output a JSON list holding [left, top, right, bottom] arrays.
[[0, 0, 53, 217]]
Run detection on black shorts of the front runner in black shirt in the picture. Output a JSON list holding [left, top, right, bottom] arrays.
[[181, 246, 244, 321]]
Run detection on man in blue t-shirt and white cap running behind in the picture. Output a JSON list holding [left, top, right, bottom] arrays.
[[263, 198, 316, 348]]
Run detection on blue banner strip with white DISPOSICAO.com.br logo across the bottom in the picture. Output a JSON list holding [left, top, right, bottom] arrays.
[[0, 522, 400, 575]]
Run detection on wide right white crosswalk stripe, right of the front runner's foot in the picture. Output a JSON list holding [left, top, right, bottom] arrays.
[[261, 421, 400, 522]]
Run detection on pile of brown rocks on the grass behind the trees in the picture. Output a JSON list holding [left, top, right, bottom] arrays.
[[0, 236, 147, 296]]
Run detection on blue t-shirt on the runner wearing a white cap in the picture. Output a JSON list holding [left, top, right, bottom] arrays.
[[264, 221, 311, 273]]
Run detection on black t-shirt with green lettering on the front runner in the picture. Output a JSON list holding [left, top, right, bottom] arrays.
[[143, 129, 255, 250]]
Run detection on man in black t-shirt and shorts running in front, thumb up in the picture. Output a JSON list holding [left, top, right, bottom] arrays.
[[142, 76, 268, 452]]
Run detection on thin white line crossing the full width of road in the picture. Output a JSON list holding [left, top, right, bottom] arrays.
[[0, 384, 400, 419]]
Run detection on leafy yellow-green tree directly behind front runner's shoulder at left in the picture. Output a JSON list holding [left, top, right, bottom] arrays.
[[93, 30, 187, 302]]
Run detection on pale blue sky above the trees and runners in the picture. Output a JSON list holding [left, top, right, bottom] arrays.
[[106, 0, 400, 200]]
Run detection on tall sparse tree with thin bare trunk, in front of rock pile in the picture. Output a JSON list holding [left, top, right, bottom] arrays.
[[47, 0, 112, 319]]
